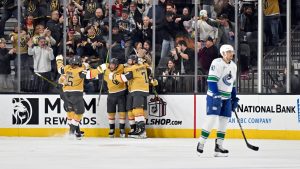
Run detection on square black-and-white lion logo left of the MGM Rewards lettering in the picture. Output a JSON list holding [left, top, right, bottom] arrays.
[[12, 98, 39, 125]]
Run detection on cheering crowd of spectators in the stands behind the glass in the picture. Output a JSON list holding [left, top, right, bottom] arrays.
[[0, 0, 286, 93]]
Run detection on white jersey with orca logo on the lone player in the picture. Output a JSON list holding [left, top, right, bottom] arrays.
[[207, 58, 237, 100]]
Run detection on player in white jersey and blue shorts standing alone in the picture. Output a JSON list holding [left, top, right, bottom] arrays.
[[197, 44, 239, 156]]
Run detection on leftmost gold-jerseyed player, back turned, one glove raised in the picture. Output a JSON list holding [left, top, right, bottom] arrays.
[[56, 55, 102, 139]]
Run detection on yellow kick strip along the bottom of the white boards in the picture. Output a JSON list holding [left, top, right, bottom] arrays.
[[0, 128, 300, 140]]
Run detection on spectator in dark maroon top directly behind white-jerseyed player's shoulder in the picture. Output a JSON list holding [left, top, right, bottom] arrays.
[[198, 37, 219, 75]]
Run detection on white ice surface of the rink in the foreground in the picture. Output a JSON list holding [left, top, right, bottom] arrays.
[[0, 137, 300, 169]]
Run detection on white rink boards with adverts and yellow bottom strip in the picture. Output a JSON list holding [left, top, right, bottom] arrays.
[[0, 95, 300, 140]]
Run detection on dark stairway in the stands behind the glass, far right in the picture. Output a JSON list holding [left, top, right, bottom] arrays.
[[240, 25, 300, 94]]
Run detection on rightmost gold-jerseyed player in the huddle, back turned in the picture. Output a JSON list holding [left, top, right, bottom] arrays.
[[110, 55, 156, 138]]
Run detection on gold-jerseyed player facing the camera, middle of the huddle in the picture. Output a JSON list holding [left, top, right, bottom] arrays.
[[87, 58, 126, 138]]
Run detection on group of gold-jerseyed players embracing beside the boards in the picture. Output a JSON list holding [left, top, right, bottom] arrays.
[[56, 55, 158, 139]]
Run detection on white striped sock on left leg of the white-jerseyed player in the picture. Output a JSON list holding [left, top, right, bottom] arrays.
[[199, 115, 218, 144]]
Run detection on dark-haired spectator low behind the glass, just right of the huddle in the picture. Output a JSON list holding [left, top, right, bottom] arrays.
[[162, 59, 179, 93]]
